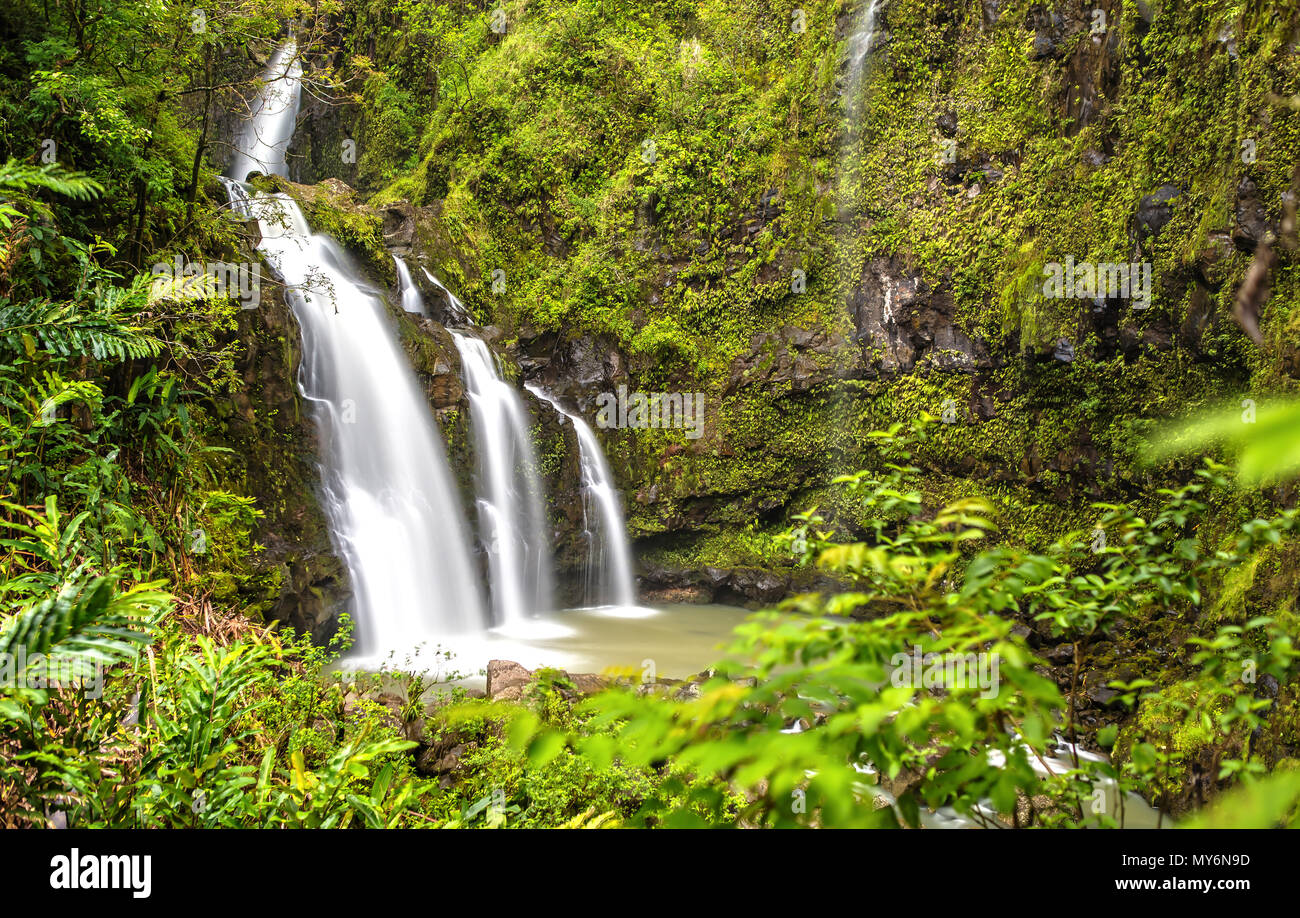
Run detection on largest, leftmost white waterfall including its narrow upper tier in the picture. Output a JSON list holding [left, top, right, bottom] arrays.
[[228, 42, 486, 658]]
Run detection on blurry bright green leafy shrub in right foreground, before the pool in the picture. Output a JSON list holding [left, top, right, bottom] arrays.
[[504, 425, 1296, 826]]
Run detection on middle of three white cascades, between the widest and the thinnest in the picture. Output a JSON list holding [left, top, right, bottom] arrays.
[[451, 332, 554, 625]]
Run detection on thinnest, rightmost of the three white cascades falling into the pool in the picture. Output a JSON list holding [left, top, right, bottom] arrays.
[[528, 386, 637, 607]]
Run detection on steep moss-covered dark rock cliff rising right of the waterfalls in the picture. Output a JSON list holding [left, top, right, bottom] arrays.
[[261, 0, 1300, 800]]
